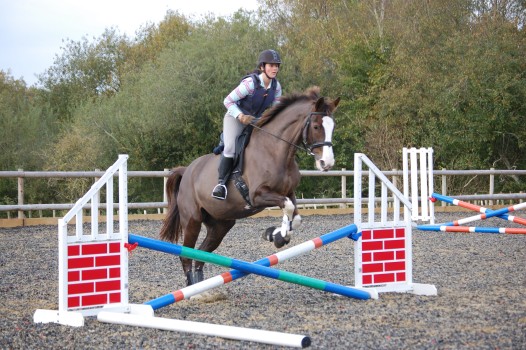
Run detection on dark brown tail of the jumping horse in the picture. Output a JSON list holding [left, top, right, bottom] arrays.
[[159, 167, 186, 242]]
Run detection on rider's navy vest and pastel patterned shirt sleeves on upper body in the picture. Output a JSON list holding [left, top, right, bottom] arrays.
[[223, 73, 281, 118]]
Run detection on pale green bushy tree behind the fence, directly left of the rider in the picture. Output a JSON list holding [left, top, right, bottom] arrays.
[[44, 11, 275, 204]]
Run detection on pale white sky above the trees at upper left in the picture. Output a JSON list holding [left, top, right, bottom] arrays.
[[0, 0, 258, 86]]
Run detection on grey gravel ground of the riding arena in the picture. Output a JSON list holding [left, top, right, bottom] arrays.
[[0, 213, 526, 349]]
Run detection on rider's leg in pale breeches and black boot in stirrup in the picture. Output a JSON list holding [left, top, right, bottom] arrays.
[[212, 114, 244, 199]]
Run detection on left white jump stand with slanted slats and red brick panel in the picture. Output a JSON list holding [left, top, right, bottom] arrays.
[[33, 155, 146, 327]]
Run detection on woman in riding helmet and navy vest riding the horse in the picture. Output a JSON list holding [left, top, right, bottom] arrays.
[[212, 50, 281, 200]]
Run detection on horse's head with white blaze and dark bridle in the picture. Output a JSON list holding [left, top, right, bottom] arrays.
[[303, 97, 340, 171]]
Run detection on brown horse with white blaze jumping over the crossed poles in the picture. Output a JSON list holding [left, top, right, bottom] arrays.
[[160, 87, 340, 285]]
